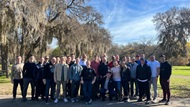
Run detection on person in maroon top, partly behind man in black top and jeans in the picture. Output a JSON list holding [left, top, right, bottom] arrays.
[[91, 55, 100, 99]]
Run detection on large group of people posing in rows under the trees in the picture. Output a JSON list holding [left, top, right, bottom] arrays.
[[11, 54, 172, 105]]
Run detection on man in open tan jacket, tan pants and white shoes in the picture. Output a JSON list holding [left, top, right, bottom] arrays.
[[54, 57, 69, 103]]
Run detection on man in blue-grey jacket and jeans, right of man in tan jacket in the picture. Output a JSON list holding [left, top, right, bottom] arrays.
[[69, 58, 83, 103]]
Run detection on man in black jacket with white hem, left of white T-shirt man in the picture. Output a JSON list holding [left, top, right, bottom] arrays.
[[136, 58, 151, 104]]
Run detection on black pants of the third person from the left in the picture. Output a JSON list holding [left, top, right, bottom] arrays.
[[35, 80, 45, 99]]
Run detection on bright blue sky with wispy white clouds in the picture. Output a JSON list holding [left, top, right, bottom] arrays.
[[50, 0, 190, 47]]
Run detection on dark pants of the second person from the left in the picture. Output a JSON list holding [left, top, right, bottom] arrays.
[[23, 78, 35, 99]]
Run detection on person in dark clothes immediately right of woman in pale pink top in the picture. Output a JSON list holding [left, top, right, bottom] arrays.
[[121, 61, 131, 102]]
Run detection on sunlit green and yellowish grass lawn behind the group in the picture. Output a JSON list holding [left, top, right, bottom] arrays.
[[0, 66, 190, 98]]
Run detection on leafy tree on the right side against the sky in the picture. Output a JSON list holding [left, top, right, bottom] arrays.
[[153, 7, 190, 57]]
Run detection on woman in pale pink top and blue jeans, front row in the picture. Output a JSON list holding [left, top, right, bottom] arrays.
[[111, 61, 121, 101]]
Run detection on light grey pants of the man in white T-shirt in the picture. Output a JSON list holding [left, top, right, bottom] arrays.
[[150, 77, 158, 99]]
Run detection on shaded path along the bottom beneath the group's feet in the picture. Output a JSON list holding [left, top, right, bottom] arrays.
[[0, 95, 190, 107]]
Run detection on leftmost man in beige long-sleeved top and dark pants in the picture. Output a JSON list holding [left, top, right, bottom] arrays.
[[11, 56, 24, 101]]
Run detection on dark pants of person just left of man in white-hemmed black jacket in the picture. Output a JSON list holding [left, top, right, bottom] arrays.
[[130, 78, 139, 96]]
